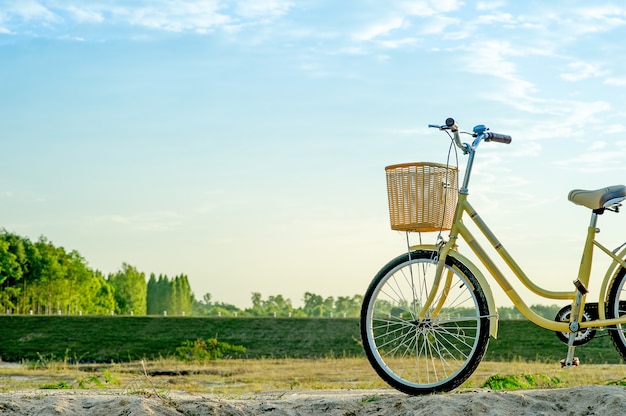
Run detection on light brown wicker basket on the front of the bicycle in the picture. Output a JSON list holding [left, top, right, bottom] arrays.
[[385, 162, 458, 232]]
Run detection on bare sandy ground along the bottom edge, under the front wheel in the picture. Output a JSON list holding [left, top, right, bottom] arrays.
[[0, 386, 626, 416]]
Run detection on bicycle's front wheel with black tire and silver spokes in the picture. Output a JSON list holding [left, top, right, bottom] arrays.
[[361, 250, 489, 395]]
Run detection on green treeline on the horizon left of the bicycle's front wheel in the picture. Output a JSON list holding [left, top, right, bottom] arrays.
[[0, 229, 363, 317]]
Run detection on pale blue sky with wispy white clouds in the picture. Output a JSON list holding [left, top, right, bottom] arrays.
[[0, 0, 626, 307]]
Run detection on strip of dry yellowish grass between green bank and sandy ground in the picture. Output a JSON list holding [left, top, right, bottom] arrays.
[[0, 358, 626, 397]]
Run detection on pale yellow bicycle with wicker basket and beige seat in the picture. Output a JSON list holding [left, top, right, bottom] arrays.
[[360, 118, 626, 395]]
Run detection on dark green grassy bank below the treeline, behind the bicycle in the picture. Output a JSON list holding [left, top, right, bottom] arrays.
[[0, 315, 622, 364]]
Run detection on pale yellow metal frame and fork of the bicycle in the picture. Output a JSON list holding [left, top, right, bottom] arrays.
[[411, 143, 626, 337]]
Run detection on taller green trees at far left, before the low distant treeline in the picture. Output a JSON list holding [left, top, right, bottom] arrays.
[[0, 229, 195, 315]]
